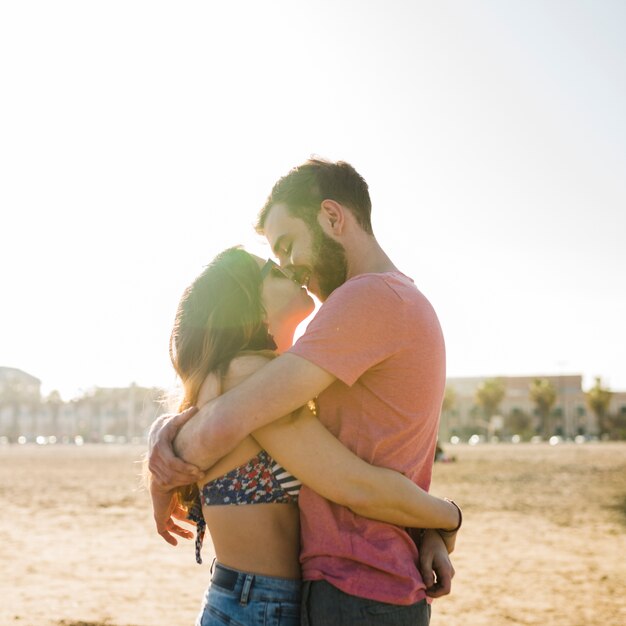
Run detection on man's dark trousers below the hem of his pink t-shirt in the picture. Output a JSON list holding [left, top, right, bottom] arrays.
[[301, 580, 430, 626]]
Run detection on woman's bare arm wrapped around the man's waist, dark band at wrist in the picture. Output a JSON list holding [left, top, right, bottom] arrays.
[[253, 407, 459, 530]]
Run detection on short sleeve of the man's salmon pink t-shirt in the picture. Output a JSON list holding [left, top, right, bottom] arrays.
[[289, 274, 404, 386]]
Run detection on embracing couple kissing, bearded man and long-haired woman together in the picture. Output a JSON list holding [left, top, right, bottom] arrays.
[[149, 159, 461, 626]]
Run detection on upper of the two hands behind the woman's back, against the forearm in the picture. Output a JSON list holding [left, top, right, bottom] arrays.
[[148, 407, 204, 493]]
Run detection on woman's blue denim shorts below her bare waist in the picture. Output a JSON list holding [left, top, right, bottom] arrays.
[[196, 563, 301, 626]]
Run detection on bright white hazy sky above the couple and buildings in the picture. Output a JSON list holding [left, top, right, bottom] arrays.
[[0, 0, 626, 399]]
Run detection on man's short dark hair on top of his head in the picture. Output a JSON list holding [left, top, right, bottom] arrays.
[[256, 157, 373, 235]]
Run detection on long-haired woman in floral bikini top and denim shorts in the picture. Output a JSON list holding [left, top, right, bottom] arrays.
[[154, 248, 461, 626]]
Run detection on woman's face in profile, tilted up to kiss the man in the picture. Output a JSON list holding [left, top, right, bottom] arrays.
[[255, 257, 315, 334]]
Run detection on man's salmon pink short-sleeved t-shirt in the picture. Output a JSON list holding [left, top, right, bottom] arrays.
[[290, 272, 445, 605]]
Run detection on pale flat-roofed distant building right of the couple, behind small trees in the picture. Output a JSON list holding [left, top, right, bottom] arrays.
[[440, 374, 626, 441]]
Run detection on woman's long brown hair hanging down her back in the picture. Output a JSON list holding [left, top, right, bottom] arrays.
[[170, 248, 276, 508]]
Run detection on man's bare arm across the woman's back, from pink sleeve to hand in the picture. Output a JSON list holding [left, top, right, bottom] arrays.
[[149, 354, 335, 486]]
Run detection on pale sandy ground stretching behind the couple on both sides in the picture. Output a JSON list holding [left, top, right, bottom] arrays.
[[0, 443, 626, 626]]
